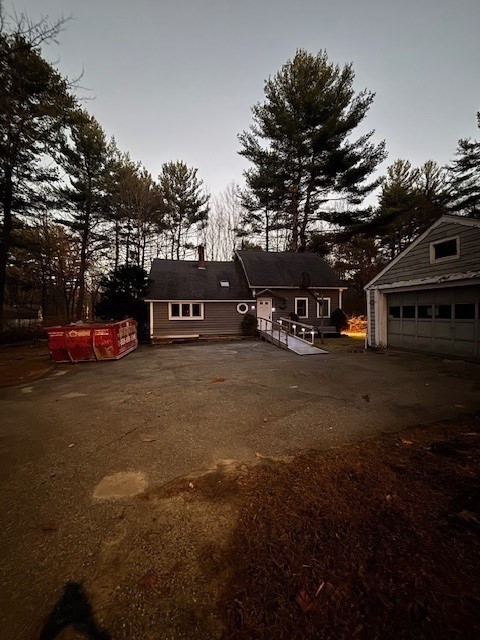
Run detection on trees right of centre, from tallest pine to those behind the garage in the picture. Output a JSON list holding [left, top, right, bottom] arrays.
[[239, 50, 480, 313]]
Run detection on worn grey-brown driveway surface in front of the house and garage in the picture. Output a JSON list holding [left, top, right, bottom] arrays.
[[0, 341, 480, 640]]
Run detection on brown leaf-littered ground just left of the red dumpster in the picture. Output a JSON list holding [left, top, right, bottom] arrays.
[[0, 344, 55, 387]]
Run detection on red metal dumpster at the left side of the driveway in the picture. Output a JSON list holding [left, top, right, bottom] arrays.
[[45, 318, 138, 362]]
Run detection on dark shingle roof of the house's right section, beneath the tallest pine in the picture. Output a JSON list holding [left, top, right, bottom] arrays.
[[237, 251, 340, 287]]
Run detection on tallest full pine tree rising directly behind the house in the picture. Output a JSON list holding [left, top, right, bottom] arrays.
[[239, 49, 385, 251]]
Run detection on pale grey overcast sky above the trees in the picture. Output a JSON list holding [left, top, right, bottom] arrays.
[[4, 0, 480, 198]]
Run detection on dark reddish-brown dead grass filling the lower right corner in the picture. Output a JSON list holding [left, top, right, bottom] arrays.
[[222, 418, 480, 640]]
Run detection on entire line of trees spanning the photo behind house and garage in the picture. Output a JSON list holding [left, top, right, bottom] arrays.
[[0, 12, 480, 322]]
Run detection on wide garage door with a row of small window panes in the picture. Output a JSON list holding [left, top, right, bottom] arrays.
[[387, 286, 480, 358]]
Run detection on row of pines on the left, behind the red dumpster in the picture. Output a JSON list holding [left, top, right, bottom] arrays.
[[0, 11, 210, 325]]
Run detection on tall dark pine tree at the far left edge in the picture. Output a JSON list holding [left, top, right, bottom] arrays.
[[0, 8, 74, 330]]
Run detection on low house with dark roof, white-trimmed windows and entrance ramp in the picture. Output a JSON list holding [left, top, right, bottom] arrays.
[[146, 247, 343, 341]]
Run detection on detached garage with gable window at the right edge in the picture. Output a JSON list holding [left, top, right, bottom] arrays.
[[365, 215, 480, 358]]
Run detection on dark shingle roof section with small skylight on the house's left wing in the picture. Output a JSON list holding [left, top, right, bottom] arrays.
[[147, 258, 252, 300]]
